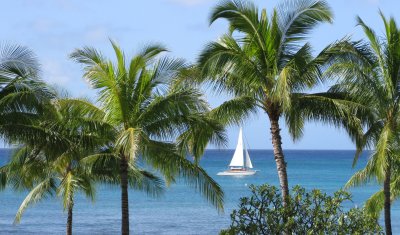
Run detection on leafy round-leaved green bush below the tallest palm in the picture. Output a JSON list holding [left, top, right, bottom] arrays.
[[220, 184, 382, 235]]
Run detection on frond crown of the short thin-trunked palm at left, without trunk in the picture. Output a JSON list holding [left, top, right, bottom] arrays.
[[0, 98, 104, 223]]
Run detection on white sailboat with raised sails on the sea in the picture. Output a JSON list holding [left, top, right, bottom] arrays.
[[217, 128, 256, 175]]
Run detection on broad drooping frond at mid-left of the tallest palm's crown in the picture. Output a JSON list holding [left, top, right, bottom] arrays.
[[198, 35, 264, 95]]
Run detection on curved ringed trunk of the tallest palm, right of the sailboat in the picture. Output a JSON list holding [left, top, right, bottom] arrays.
[[269, 115, 289, 206]]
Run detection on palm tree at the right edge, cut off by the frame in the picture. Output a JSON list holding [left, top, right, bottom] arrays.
[[329, 12, 400, 234]]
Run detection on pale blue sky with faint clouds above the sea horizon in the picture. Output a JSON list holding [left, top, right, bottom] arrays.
[[0, 0, 400, 149]]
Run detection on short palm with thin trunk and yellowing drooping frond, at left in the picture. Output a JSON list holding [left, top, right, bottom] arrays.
[[0, 99, 163, 234]]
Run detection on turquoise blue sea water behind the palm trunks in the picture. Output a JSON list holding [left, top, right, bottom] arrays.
[[0, 149, 400, 235]]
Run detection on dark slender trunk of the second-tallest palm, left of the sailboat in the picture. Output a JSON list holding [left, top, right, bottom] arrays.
[[120, 156, 129, 235]]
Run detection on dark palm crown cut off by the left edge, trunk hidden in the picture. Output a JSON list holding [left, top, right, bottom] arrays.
[[0, 45, 54, 143]]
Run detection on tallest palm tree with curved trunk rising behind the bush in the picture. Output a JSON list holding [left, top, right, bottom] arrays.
[[198, 0, 332, 203]]
